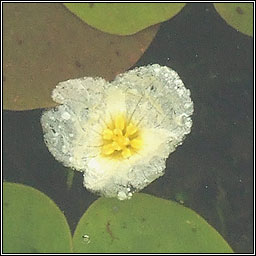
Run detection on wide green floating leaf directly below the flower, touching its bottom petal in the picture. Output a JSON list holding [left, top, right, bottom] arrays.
[[73, 193, 232, 253]]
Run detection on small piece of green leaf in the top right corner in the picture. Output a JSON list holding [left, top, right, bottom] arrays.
[[214, 3, 253, 36]]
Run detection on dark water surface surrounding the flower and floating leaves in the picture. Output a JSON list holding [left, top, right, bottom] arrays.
[[3, 3, 254, 253]]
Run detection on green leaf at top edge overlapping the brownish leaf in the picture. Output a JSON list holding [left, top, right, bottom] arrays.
[[64, 3, 185, 35]]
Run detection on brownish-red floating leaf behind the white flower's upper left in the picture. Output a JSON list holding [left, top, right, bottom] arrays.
[[3, 3, 159, 110]]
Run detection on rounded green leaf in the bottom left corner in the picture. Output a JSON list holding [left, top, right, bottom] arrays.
[[3, 182, 72, 253]]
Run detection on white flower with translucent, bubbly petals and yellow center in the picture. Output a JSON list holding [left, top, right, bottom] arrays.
[[41, 64, 193, 200]]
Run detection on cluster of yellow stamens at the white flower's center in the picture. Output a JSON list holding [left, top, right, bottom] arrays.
[[101, 115, 142, 158]]
